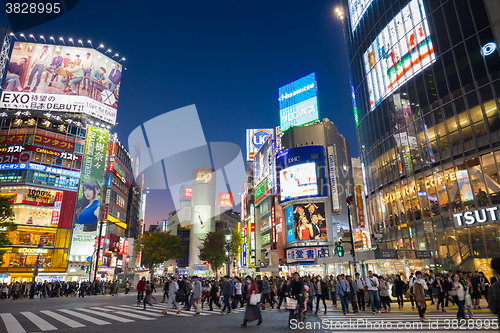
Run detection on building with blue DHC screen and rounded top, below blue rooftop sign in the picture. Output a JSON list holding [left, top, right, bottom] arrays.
[[276, 118, 354, 275]]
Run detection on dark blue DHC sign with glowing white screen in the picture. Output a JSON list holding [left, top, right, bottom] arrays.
[[276, 146, 329, 202]]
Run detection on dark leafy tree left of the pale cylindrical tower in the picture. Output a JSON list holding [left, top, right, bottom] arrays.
[[134, 232, 185, 275]]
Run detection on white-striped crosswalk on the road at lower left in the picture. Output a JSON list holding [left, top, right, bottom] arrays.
[[0, 303, 245, 333]]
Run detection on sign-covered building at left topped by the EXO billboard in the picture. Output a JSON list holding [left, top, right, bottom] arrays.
[[0, 34, 132, 281]]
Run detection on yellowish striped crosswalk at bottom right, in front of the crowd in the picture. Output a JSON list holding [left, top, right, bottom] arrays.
[[318, 309, 499, 333]]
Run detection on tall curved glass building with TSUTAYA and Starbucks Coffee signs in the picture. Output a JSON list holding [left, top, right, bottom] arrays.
[[343, 0, 500, 272]]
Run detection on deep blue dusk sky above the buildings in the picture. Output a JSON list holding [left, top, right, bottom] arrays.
[[0, 0, 358, 225]]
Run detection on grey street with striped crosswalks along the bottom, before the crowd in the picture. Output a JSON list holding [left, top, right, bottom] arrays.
[[0, 293, 498, 333]]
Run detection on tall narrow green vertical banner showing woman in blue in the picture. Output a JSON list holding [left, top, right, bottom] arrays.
[[70, 126, 109, 256]]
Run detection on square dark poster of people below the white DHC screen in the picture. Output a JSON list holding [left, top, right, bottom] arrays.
[[293, 202, 327, 241]]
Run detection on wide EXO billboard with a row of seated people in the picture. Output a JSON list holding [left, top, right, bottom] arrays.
[[0, 42, 123, 125]]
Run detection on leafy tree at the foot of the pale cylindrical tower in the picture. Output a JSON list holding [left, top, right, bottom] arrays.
[[199, 229, 243, 272]]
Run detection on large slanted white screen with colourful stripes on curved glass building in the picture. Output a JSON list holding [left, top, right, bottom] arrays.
[[363, 0, 435, 110]]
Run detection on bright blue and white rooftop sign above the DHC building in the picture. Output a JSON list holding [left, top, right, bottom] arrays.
[[278, 73, 319, 132]]
